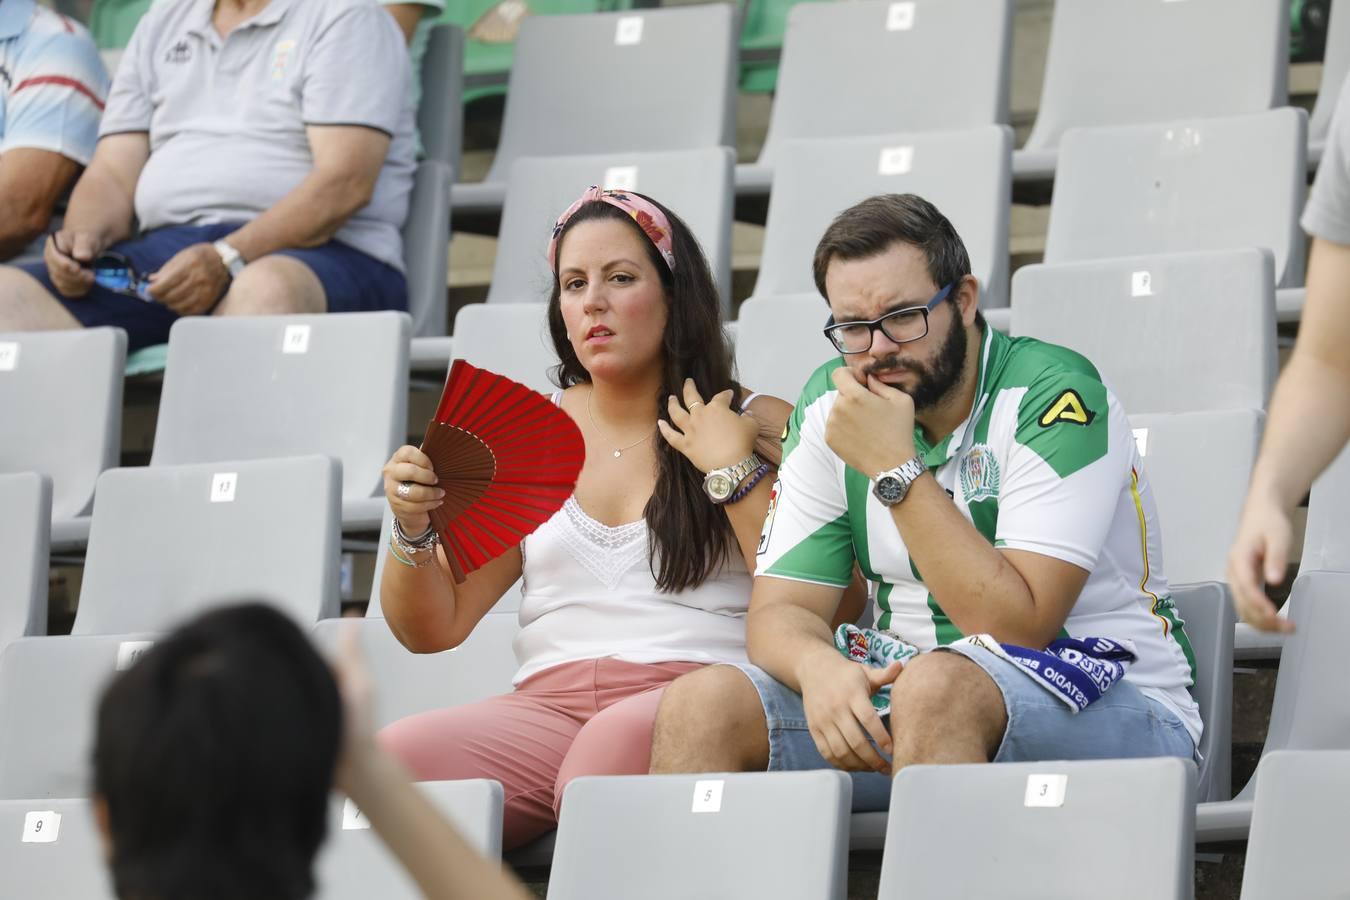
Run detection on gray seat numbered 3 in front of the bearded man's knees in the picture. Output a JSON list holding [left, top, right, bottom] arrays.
[[879, 758, 1195, 900]]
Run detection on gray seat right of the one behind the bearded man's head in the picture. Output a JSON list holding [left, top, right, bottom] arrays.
[[1045, 107, 1307, 287]]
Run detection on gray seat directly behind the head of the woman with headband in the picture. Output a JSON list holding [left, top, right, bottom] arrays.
[[487, 147, 734, 313]]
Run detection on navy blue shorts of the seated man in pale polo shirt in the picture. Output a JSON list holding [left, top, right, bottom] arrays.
[[19, 223, 408, 351]]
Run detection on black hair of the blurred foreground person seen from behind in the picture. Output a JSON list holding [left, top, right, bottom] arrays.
[[93, 603, 342, 900]]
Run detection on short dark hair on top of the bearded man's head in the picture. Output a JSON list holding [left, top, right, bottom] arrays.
[[811, 194, 984, 331]]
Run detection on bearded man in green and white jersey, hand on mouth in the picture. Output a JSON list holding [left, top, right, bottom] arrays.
[[652, 194, 1202, 810]]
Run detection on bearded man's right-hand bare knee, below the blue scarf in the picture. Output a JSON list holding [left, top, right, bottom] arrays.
[[891, 652, 1007, 772]]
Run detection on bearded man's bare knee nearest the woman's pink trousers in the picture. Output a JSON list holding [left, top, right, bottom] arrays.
[[652, 665, 768, 772]]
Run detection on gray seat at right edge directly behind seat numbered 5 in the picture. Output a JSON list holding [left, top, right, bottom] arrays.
[[1196, 572, 1350, 841]]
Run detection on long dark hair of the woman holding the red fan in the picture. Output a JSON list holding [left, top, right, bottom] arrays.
[[548, 192, 741, 592]]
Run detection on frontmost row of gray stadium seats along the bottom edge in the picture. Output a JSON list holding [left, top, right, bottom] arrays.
[[0, 752, 1350, 900]]
